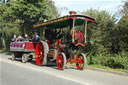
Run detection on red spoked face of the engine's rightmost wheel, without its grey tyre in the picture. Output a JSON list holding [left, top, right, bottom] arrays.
[[76, 55, 85, 70]]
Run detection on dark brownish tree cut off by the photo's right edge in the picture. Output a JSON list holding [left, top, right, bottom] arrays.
[[116, 1, 128, 52]]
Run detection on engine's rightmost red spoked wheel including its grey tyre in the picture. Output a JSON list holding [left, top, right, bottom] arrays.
[[76, 53, 86, 70]]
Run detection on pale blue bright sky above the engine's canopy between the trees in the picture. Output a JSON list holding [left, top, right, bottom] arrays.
[[53, 0, 126, 15]]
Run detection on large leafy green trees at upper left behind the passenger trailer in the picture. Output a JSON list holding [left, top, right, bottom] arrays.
[[0, 0, 57, 47]]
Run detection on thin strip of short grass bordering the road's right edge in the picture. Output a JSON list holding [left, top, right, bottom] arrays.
[[87, 65, 128, 73]]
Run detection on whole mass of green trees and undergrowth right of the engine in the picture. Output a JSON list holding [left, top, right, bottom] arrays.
[[82, 2, 128, 69]]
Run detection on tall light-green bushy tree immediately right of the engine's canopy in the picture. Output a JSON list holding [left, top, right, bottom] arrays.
[[82, 9, 116, 55]]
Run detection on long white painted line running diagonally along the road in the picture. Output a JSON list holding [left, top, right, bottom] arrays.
[[0, 58, 90, 85]]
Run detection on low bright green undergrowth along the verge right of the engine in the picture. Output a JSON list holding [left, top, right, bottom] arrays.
[[87, 52, 128, 69]]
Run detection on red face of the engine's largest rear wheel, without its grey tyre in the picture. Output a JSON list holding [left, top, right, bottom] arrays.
[[35, 42, 44, 66]]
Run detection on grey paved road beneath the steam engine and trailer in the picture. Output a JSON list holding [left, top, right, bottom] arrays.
[[0, 54, 128, 85]]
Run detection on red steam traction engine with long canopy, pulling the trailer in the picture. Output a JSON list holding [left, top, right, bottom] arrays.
[[33, 12, 95, 70]]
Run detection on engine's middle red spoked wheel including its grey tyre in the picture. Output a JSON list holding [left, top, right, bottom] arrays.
[[56, 53, 66, 70]]
